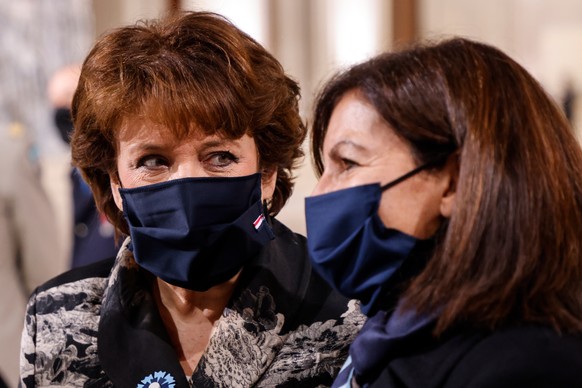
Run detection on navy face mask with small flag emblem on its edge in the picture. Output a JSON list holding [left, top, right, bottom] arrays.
[[119, 173, 275, 291]]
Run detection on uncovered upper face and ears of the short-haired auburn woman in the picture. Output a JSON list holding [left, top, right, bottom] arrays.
[[110, 119, 277, 209]]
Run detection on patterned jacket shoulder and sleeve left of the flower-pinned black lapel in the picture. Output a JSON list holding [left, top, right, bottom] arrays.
[[20, 259, 115, 386]]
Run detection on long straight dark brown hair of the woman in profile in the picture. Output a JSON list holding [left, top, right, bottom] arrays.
[[312, 38, 582, 333]]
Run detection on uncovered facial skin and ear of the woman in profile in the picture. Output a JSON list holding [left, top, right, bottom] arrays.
[[313, 91, 456, 238]]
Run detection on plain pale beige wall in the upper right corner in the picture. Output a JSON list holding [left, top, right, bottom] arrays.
[[419, 0, 582, 138]]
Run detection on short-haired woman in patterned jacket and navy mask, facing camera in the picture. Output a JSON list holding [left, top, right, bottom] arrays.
[[21, 12, 363, 388]]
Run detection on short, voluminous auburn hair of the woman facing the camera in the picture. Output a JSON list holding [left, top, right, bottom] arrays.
[[71, 12, 306, 234]]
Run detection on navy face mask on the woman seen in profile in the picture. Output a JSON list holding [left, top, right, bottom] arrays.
[[305, 162, 434, 316]]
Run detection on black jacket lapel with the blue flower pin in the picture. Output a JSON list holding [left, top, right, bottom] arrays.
[[98, 241, 189, 388]]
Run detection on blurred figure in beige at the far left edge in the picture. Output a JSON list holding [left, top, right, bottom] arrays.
[[0, 119, 61, 387]]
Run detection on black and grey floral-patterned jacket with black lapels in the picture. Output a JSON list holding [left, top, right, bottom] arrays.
[[20, 220, 365, 388]]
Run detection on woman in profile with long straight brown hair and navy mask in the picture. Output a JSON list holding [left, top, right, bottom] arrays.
[[306, 39, 582, 388]]
